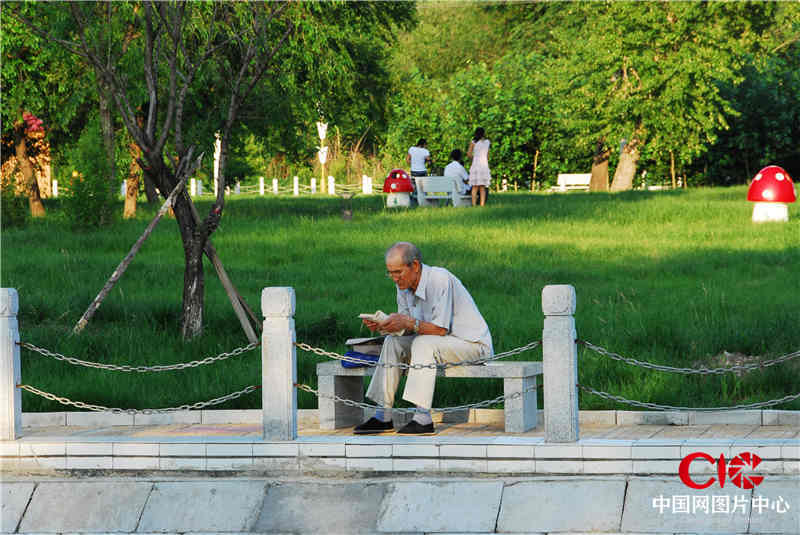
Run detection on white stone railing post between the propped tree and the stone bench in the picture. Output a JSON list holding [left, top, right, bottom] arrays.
[[261, 286, 297, 440]]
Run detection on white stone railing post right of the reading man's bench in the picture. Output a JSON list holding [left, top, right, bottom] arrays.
[[542, 284, 578, 442]]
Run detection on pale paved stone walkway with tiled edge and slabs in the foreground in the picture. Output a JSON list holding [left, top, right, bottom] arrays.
[[0, 411, 800, 535]]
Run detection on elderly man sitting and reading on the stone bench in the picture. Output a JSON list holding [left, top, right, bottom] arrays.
[[355, 242, 493, 435]]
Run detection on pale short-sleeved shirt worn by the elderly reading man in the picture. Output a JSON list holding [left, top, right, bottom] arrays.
[[397, 264, 494, 354]]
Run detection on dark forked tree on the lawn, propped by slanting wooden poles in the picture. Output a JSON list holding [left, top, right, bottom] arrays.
[[11, 1, 292, 338]]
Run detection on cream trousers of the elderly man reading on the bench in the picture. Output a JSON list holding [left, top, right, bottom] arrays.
[[367, 334, 489, 409]]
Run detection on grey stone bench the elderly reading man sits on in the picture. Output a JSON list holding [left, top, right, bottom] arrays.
[[317, 361, 542, 433]]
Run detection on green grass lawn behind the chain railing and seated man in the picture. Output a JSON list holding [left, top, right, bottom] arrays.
[[0, 187, 800, 411]]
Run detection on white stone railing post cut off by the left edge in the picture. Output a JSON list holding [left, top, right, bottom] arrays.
[[0, 288, 22, 440]]
